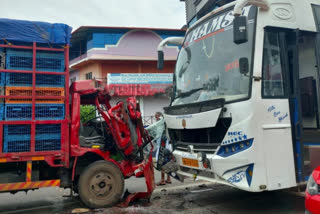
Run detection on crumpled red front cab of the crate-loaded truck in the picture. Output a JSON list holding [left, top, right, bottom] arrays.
[[71, 80, 155, 207]]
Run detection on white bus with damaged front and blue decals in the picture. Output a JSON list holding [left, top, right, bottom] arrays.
[[158, 0, 320, 192]]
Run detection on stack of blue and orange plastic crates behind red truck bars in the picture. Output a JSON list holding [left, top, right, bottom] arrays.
[[0, 18, 68, 154]]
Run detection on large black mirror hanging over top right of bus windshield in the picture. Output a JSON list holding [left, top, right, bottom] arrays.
[[233, 16, 248, 45]]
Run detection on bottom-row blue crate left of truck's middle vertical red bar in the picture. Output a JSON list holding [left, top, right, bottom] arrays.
[[3, 138, 31, 153]]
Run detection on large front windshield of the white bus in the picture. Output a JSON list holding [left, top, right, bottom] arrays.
[[172, 6, 257, 106]]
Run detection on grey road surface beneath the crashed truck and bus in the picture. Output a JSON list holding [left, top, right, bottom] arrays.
[[0, 172, 304, 214]]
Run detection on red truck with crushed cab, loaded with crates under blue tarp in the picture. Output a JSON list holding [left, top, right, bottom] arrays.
[[0, 19, 155, 208]]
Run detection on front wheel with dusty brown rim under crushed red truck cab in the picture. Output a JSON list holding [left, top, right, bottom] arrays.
[[78, 161, 124, 208]]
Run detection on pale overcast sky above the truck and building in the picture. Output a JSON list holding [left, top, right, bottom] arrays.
[[0, 0, 186, 30]]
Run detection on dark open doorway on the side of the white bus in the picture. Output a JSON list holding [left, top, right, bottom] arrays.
[[281, 6, 320, 183]]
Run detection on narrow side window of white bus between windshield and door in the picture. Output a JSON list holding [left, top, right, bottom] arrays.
[[262, 32, 285, 98]]
